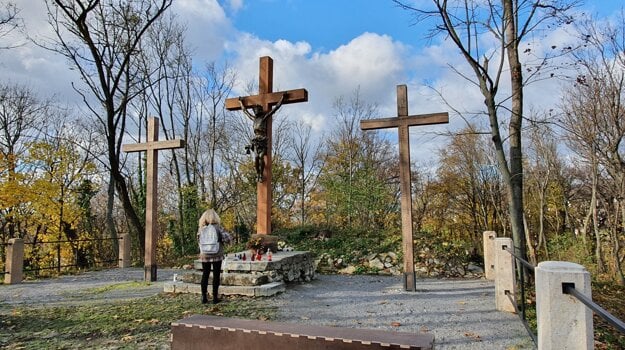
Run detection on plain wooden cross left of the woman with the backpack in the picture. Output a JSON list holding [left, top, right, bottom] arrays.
[[122, 118, 184, 282]]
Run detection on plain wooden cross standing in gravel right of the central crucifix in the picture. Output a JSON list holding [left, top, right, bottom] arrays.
[[360, 85, 449, 291]]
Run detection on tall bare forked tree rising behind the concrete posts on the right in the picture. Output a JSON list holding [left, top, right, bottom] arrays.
[[393, 0, 572, 255]]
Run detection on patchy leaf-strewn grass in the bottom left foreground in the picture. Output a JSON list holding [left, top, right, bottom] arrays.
[[0, 293, 276, 349]]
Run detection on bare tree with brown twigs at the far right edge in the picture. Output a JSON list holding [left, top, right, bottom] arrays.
[[561, 15, 625, 284]]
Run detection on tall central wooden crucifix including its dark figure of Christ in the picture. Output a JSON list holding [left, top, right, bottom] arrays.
[[226, 56, 308, 234]]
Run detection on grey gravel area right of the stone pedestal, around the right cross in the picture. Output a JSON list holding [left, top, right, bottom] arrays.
[[272, 275, 534, 349]]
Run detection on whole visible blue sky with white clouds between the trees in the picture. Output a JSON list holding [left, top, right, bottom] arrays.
[[0, 0, 625, 161]]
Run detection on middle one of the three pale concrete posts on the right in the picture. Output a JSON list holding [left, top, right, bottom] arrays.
[[494, 237, 516, 313]]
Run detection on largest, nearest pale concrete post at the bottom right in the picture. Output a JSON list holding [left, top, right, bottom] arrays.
[[535, 261, 594, 350]]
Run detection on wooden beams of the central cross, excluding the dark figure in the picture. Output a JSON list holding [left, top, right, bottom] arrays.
[[226, 56, 308, 234]]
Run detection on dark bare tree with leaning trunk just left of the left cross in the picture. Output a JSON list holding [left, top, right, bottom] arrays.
[[46, 0, 172, 256]]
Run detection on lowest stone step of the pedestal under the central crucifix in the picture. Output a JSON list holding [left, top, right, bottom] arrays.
[[164, 281, 286, 297]]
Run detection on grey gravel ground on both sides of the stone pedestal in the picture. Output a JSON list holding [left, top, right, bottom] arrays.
[[0, 268, 534, 349]]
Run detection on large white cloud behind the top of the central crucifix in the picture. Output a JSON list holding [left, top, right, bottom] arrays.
[[226, 33, 406, 130]]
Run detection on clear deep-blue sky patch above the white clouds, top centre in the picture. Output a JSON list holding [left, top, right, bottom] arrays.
[[232, 0, 415, 52]]
